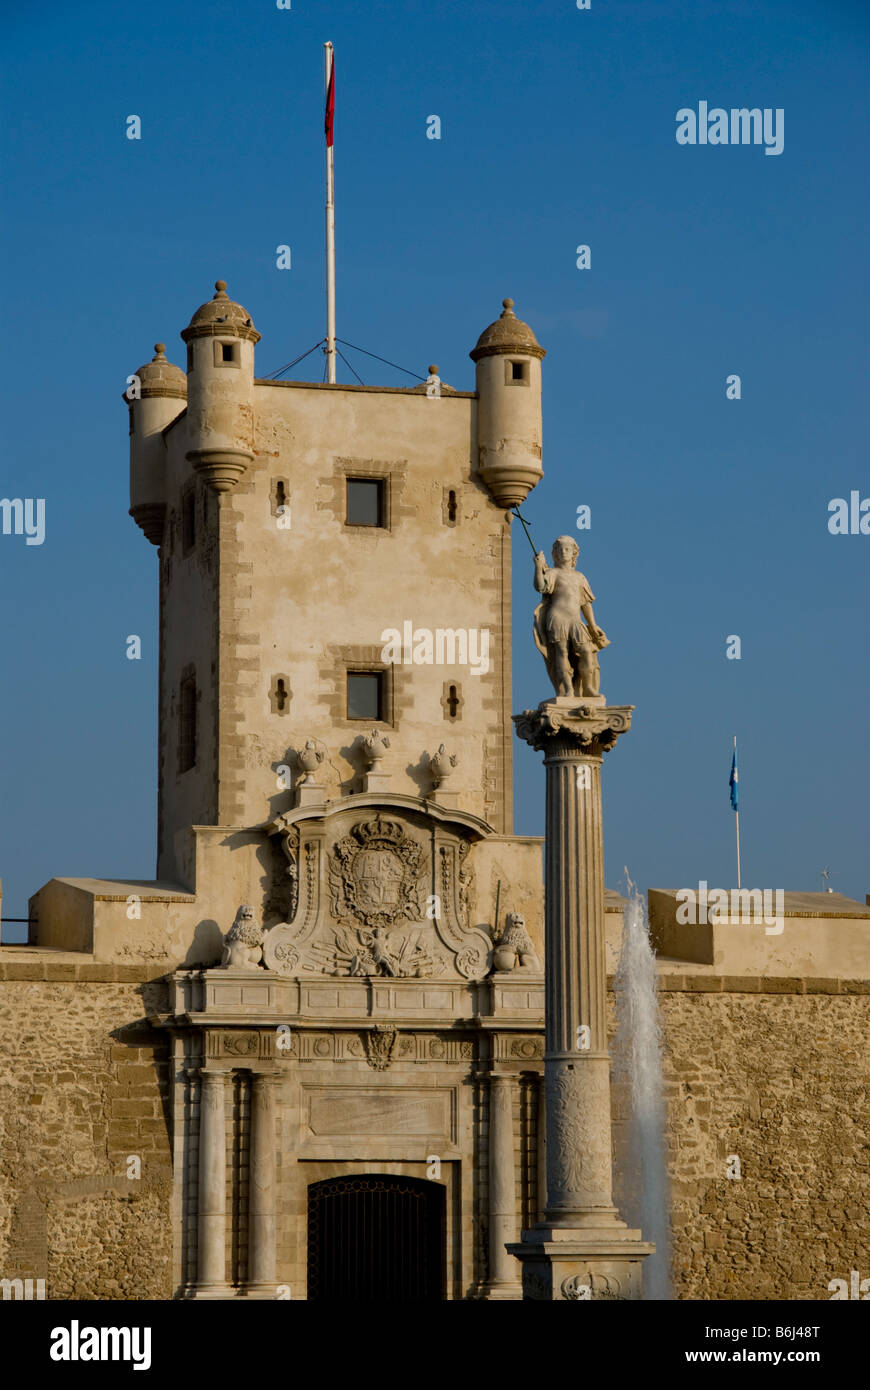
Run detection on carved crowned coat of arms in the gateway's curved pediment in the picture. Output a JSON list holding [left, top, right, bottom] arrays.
[[329, 816, 424, 927]]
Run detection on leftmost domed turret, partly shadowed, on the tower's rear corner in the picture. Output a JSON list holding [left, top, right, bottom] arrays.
[[124, 343, 188, 545]]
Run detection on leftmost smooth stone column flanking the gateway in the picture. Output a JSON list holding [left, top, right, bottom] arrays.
[[196, 1069, 229, 1298]]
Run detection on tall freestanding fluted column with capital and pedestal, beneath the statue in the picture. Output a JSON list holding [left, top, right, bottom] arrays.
[[511, 696, 655, 1300]]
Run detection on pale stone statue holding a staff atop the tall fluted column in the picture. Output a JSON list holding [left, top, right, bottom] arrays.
[[535, 535, 610, 695]]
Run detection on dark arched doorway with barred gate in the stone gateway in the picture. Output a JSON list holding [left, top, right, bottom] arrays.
[[309, 1173, 445, 1302]]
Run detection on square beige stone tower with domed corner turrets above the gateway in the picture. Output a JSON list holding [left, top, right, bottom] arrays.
[[123, 281, 543, 883]]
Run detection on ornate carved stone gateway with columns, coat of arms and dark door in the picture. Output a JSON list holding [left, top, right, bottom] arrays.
[[161, 787, 543, 1302]]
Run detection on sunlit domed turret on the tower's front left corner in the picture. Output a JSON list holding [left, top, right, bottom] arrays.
[[181, 279, 260, 492]]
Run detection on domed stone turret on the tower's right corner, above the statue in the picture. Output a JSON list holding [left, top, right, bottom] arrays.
[[470, 299, 545, 507]]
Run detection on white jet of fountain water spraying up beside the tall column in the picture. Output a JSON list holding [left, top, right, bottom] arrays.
[[612, 870, 671, 1300]]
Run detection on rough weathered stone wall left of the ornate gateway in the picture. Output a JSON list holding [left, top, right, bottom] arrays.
[[0, 959, 172, 1300]]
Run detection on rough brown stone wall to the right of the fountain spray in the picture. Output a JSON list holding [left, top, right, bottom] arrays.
[[636, 976, 870, 1300]]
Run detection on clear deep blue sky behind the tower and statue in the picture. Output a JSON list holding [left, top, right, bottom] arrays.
[[0, 0, 870, 937]]
